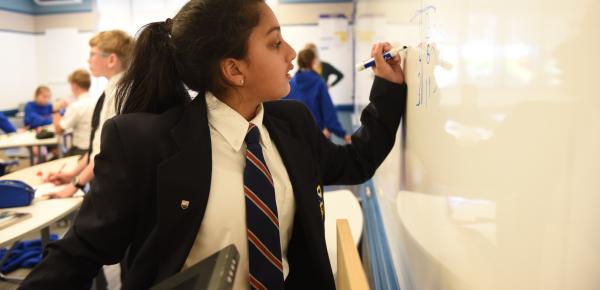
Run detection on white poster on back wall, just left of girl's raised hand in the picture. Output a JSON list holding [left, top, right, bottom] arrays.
[[317, 14, 354, 106]]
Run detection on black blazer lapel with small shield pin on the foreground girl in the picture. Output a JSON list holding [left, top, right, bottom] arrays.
[[156, 95, 212, 281]]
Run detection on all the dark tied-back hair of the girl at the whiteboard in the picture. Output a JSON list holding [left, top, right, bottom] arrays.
[[117, 0, 264, 114]]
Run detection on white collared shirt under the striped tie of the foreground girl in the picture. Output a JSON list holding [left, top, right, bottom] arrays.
[[182, 93, 295, 290]]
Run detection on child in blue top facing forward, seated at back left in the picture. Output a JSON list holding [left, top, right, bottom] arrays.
[[24, 86, 64, 129]]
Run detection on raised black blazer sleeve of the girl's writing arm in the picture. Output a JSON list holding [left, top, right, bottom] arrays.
[[312, 77, 407, 185]]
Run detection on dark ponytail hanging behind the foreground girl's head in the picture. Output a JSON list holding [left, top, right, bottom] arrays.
[[116, 21, 190, 114]]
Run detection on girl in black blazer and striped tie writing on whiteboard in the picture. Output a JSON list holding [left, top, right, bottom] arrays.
[[20, 0, 406, 290]]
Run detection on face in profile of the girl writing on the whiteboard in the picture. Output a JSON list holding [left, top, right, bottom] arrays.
[[238, 3, 296, 102]]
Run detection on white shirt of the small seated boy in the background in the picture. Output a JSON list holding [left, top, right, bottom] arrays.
[[59, 93, 96, 149]]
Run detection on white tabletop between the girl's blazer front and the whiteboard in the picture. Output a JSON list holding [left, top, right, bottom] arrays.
[[323, 189, 363, 275]]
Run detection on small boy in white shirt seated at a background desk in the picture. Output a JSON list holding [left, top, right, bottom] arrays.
[[52, 69, 95, 156]]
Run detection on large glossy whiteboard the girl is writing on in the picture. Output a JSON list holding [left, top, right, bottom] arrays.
[[356, 0, 600, 290]]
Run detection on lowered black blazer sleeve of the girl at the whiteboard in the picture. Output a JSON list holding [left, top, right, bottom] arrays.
[[19, 120, 136, 289]]
